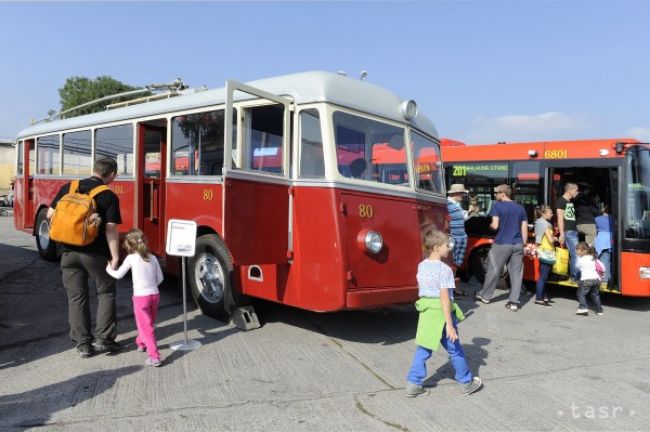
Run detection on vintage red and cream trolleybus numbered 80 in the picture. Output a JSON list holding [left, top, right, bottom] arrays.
[[14, 72, 447, 319]]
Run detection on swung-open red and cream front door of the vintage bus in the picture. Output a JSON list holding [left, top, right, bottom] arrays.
[[222, 81, 293, 265]]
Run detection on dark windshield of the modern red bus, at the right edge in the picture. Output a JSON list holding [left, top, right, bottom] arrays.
[[625, 146, 650, 239]]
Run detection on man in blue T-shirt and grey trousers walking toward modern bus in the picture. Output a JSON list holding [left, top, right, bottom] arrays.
[[476, 184, 528, 311]]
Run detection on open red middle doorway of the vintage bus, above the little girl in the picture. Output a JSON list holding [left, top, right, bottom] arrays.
[[136, 120, 167, 255]]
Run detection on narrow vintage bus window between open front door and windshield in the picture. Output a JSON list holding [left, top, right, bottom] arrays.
[[300, 109, 325, 178]]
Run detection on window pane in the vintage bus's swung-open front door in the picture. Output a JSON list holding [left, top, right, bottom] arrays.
[[243, 104, 285, 174]]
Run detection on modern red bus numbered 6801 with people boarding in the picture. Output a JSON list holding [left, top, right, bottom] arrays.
[[443, 139, 650, 297]]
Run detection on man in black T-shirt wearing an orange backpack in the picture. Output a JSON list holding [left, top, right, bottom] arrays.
[[47, 158, 122, 358]]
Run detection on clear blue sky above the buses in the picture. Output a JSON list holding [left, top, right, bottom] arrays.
[[0, 0, 650, 143]]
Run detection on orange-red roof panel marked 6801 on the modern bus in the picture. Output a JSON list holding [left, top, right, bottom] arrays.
[[441, 138, 639, 161]]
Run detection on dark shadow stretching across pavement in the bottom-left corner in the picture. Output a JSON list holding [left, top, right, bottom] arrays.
[[0, 366, 142, 429]]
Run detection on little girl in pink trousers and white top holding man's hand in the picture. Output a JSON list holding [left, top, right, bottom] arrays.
[[106, 229, 163, 367]]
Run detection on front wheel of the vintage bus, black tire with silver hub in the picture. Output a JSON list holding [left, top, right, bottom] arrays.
[[187, 234, 246, 323]]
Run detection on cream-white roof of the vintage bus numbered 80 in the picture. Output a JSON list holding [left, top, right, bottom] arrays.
[[18, 72, 438, 139]]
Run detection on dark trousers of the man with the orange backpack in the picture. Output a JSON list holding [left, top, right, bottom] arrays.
[[61, 251, 117, 346]]
